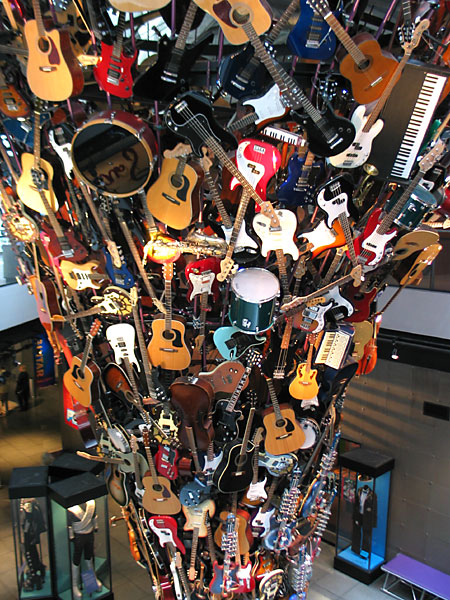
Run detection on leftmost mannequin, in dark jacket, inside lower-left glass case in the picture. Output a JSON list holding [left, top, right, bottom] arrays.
[[20, 498, 47, 591]]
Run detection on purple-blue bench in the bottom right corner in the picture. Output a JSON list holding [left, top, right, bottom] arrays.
[[381, 554, 450, 600]]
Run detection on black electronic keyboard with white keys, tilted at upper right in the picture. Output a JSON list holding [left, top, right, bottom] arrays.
[[367, 61, 449, 183]]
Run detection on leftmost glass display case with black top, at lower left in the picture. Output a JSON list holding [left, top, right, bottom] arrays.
[[8, 467, 54, 600]]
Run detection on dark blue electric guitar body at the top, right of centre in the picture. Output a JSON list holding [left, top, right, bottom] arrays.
[[287, 0, 340, 61]]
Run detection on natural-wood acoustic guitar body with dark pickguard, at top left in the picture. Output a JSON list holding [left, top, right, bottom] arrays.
[[24, 19, 84, 102]]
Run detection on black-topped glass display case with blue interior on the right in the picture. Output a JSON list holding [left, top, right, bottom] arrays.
[[334, 448, 394, 583]]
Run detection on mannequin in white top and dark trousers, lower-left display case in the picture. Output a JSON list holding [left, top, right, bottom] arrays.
[[67, 500, 102, 599]]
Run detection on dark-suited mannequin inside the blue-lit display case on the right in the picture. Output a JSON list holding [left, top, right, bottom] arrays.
[[352, 475, 377, 555]]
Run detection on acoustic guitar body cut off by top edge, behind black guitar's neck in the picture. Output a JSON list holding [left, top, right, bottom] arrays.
[[195, 0, 272, 45]]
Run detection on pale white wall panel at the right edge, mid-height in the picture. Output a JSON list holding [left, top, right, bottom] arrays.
[[378, 286, 450, 339]]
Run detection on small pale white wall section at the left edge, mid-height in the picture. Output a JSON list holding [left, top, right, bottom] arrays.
[[0, 283, 38, 331]]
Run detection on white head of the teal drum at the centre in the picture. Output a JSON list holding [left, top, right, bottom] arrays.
[[231, 267, 280, 304]]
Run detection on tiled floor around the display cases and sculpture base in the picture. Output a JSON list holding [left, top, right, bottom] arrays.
[[0, 380, 387, 600]]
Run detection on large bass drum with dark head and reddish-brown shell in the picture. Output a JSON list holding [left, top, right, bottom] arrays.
[[72, 110, 158, 198]]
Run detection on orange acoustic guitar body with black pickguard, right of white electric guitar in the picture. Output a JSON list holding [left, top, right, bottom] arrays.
[[147, 318, 191, 371]]
